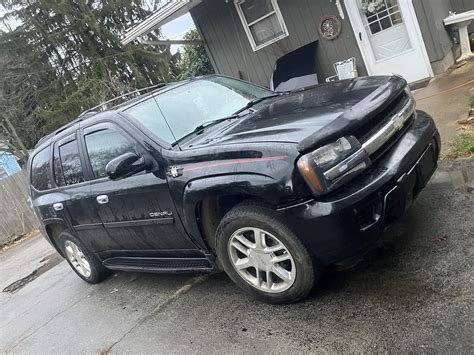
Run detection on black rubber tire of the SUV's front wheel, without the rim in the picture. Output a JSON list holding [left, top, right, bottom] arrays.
[[216, 204, 319, 304]]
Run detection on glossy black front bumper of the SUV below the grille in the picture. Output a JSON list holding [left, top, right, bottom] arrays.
[[278, 111, 440, 265]]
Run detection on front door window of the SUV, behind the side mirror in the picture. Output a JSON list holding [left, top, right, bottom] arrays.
[[85, 129, 135, 178]]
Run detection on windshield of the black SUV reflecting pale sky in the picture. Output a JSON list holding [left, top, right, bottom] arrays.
[[127, 75, 273, 143]]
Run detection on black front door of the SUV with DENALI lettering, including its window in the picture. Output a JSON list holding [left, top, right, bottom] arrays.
[[82, 123, 196, 252]]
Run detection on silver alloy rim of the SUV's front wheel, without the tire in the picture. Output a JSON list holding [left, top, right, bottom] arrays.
[[227, 227, 296, 293]]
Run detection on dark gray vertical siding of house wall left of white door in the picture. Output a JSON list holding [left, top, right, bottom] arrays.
[[191, 0, 367, 86]]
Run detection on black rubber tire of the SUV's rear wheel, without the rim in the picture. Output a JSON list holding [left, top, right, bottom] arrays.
[[59, 231, 110, 284]]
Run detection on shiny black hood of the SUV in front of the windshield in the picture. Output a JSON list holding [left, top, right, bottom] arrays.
[[182, 76, 406, 151]]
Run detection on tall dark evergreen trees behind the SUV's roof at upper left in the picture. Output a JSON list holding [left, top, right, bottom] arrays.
[[0, 0, 176, 147]]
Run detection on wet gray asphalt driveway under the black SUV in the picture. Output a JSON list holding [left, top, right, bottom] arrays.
[[0, 163, 474, 354]]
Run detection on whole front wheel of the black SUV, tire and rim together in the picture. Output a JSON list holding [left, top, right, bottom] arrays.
[[216, 201, 322, 304]]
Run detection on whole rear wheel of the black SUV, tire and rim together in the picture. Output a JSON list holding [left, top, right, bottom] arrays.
[[59, 231, 110, 284]]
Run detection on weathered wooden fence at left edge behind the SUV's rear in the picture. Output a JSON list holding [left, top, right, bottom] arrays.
[[0, 170, 38, 241]]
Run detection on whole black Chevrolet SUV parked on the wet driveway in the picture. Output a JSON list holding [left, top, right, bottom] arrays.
[[28, 75, 440, 303]]
